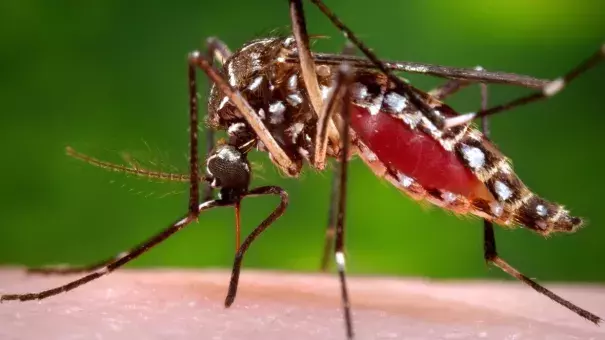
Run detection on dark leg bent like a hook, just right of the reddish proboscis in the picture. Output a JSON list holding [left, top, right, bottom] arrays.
[[225, 186, 288, 307]]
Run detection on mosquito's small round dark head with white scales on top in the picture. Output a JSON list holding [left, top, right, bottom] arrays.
[[206, 145, 250, 191]]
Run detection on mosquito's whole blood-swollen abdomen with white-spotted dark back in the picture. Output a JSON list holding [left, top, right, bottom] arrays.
[[351, 73, 582, 234]]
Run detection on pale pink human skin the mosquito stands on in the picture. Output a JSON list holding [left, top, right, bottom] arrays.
[[0, 268, 605, 340]]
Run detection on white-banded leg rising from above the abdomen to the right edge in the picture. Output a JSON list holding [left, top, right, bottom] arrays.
[[444, 44, 605, 128]]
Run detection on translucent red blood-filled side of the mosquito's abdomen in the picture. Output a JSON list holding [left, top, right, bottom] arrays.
[[351, 104, 486, 198]]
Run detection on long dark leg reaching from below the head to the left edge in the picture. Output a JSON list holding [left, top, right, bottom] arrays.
[[0, 201, 226, 302]]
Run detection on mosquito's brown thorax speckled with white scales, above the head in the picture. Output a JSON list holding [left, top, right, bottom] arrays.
[[208, 37, 340, 175]]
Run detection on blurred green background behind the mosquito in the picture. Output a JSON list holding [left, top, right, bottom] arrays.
[[0, 0, 605, 282]]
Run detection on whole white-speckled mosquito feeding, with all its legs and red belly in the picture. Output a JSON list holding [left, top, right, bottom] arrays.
[[0, 0, 605, 338]]
